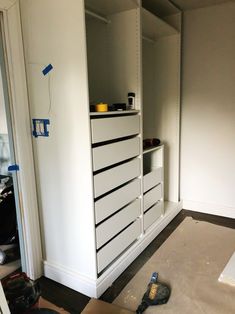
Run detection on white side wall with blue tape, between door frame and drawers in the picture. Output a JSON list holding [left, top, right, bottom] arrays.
[[21, 0, 96, 282]]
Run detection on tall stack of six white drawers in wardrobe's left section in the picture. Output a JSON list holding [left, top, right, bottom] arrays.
[[91, 114, 142, 274]]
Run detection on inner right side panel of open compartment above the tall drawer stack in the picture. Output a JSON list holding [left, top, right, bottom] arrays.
[[108, 9, 140, 109]]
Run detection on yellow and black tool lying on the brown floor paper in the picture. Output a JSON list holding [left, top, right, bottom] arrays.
[[136, 272, 170, 314]]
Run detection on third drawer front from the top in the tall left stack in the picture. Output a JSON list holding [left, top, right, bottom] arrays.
[[94, 158, 140, 197]]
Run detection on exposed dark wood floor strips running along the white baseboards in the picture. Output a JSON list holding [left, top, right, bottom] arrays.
[[39, 210, 235, 314]]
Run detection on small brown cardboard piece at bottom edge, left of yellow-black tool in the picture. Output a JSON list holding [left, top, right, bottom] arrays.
[[82, 299, 134, 314]]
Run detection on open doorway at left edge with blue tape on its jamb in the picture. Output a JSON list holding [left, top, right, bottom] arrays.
[[0, 11, 26, 279]]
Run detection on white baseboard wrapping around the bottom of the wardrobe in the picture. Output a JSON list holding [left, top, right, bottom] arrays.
[[44, 203, 182, 298]]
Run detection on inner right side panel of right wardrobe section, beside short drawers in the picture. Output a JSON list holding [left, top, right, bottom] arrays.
[[155, 34, 180, 202]]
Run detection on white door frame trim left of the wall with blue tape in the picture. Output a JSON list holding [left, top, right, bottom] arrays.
[[0, 0, 43, 279]]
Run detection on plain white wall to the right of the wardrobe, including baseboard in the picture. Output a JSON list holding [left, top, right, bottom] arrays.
[[181, 2, 235, 218]]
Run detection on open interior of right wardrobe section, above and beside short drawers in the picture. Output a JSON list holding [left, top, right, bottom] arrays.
[[142, 4, 181, 211]]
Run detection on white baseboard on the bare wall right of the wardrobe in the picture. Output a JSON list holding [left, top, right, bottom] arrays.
[[183, 200, 235, 219]]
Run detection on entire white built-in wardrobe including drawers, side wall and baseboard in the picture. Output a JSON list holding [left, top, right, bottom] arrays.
[[21, 0, 181, 297]]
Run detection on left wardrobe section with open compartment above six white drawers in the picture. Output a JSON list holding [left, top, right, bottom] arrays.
[[85, 0, 142, 276]]
